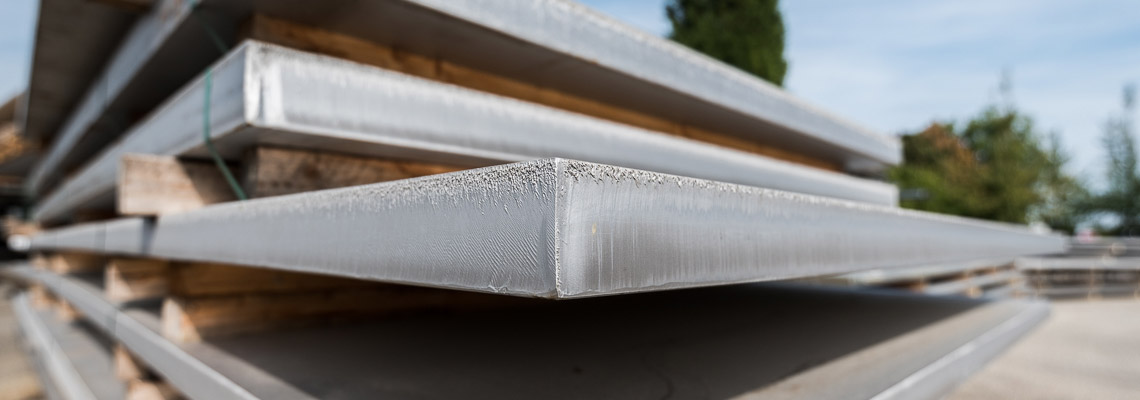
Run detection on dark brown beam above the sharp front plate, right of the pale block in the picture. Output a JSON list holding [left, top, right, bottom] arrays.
[[244, 147, 462, 197]]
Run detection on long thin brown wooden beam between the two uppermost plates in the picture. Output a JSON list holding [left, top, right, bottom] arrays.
[[244, 15, 842, 171]]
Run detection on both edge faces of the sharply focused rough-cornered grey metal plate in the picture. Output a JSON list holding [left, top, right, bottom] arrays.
[[32, 158, 1065, 299]]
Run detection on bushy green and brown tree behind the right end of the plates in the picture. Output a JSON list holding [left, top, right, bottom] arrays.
[[891, 107, 1084, 230]]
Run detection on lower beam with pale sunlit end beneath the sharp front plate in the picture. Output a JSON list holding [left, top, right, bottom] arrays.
[[162, 285, 531, 343]]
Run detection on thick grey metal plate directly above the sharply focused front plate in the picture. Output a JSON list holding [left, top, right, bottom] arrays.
[[33, 42, 897, 224]]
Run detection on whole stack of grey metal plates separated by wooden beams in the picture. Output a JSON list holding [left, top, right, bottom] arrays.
[[0, 0, 1065, 399]]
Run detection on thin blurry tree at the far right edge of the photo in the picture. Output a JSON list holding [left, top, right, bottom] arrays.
[[1086, 87, 1140, 236]]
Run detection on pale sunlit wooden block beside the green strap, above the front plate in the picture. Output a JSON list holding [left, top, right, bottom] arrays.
[[115, 154, 237, 215]]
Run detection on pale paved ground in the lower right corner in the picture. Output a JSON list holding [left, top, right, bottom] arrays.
[[948, 299, 1140, 400]]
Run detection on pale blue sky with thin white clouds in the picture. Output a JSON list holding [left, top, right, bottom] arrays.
[[0, 0, 1140, 186]]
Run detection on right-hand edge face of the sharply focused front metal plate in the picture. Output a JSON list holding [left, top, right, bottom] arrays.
[[556, 161, 1065, 296]]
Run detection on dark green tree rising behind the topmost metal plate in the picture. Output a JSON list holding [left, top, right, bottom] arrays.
[[666, 0, 788, 85]]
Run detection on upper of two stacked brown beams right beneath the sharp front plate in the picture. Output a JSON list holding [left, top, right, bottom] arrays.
[[169, 262, 371, 297]]
